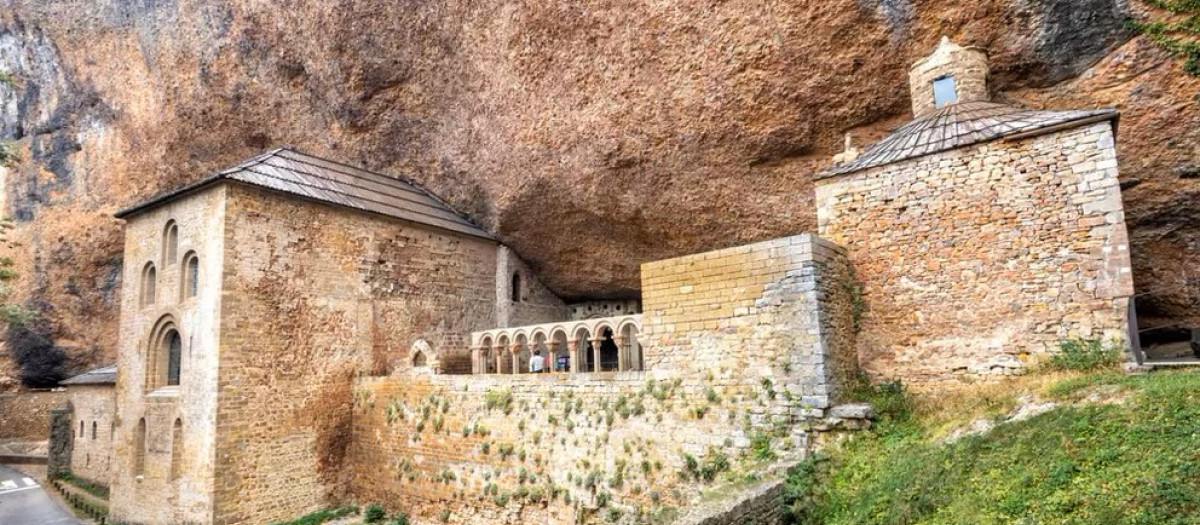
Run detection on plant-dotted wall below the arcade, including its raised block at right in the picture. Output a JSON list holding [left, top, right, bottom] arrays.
[[347, 235, 852, 525]]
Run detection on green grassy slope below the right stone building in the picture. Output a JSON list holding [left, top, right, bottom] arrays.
[[787, 372, 1200, 525]]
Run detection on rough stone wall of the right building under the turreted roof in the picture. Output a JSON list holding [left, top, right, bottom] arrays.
[[816, 122, 1133, 385]]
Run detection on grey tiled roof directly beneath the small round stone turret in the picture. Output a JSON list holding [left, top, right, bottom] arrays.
[[816, 102, 1117, 179]]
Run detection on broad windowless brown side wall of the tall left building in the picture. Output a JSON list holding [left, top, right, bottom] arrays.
[[214, 186, 556, 525]]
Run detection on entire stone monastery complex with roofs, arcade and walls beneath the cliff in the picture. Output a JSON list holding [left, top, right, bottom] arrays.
[[93, 41, 1133, 525]]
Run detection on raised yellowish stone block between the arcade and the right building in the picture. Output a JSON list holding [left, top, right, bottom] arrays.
[[642, 234, 852, 416]]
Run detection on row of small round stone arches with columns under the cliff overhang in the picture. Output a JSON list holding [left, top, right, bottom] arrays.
[[470, 314, 644, 374]]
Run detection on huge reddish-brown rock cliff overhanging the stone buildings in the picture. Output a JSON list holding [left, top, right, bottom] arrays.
[[0, 0, 1200, 384]]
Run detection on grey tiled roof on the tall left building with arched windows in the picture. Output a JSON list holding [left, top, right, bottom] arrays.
[[116, 147, 493, 239]]
